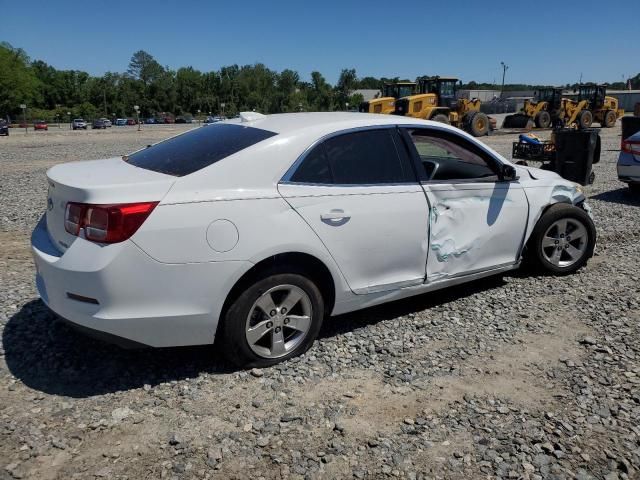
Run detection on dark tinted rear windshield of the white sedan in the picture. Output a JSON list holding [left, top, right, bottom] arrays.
[[127, 123, 276, 177]]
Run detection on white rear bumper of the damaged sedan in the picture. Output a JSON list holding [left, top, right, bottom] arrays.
[[31, 218, 250, 347]]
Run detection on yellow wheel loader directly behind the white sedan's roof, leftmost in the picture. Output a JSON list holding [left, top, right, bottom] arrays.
[[394, 76, 490, 137]]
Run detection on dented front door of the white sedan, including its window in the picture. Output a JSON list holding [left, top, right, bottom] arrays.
[[404, 128, 529, 281]]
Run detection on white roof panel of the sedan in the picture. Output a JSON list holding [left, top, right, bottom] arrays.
[[234, 112, 442, 134]]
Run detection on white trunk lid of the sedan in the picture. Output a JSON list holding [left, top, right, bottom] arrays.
[[47, 157, 176, 252]]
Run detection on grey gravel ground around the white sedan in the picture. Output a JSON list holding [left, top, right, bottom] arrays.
[[0, 122, 640, 480]]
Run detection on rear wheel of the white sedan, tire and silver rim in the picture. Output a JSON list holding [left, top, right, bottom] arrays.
[[220, 273, 324, 368]]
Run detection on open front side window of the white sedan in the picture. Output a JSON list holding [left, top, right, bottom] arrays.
[[408, 130, 498, 181]]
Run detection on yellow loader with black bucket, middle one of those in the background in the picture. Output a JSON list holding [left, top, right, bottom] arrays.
[[502, 87, 563, 128]]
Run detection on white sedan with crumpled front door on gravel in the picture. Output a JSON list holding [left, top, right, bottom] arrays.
[[32, 113, 596, 366]]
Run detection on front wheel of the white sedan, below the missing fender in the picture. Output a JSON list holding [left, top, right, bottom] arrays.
[[527, 203, 596, 275]]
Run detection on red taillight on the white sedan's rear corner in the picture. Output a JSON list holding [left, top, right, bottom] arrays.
[[64, 202, 158, 243]]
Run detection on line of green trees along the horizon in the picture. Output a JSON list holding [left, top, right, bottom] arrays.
[[0, 42, 640, 121]]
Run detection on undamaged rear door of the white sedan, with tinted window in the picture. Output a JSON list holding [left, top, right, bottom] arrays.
[[278, 127, 429, 294]]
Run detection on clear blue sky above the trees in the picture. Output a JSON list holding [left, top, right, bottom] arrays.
[[0, 0, 640, 84]]
